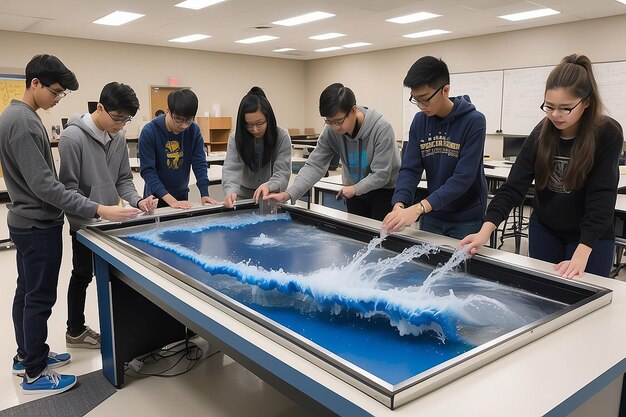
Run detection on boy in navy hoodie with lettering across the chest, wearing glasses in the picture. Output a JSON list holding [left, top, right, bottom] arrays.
[[383, 56, 487, 239]]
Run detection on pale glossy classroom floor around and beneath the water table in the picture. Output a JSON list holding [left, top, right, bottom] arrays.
[[0, 170, 626, 417]]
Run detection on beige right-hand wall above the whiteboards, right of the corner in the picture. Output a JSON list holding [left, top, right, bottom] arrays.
[[305, 15, 626, 157]]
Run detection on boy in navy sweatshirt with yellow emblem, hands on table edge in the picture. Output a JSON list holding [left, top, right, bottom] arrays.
[[137, 89, 218, 209]]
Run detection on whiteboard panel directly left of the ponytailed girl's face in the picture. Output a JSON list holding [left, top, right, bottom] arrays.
[[502, 66, 554, 135]]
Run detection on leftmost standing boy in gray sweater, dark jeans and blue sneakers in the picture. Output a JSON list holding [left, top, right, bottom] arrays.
[[0, 55, 141, 394]]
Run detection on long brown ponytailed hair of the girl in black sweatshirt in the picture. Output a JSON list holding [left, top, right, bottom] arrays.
[[535, 54, 604, 191]]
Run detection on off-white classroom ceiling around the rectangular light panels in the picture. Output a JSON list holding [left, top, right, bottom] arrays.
[[0, 0, 626, 60]]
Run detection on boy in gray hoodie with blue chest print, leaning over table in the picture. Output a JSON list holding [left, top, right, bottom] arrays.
[[268, 83, 400, 220]]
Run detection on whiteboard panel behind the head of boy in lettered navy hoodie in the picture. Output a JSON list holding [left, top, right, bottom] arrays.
[[402, 70, 504, 141]]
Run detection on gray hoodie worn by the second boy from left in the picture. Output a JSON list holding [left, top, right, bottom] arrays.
[[59, 114, 141, 230]]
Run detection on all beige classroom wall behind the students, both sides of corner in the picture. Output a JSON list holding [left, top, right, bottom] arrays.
[[0, 15, 626, 157]]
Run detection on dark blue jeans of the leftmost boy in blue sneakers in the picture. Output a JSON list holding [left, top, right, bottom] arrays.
[[9, 226, 63, 378]]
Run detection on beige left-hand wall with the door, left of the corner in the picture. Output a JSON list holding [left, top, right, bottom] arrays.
[[0, 31, 306, 135]]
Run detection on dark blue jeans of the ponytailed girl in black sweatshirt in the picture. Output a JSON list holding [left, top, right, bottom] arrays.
[[528, 217, 615, 277]]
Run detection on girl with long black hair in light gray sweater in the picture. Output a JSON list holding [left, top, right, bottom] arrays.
[[222, 87, 291, 208]]
